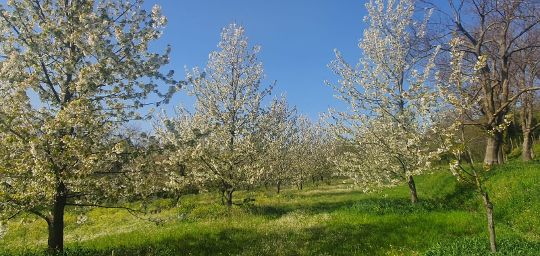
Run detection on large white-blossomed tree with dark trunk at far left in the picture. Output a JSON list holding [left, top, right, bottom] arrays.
[[0, 0, 180, 252]]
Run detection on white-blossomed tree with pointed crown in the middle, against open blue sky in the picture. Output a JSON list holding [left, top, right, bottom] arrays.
[[187, 24, 272, 206]]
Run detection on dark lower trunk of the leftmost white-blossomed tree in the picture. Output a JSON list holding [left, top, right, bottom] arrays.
[[47, 183, 66, 254]]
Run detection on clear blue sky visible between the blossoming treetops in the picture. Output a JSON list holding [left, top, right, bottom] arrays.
[[145, 0, 366, 123]]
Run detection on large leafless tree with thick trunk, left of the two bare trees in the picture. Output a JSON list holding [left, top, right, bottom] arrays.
[[442, 0, 540, 166]]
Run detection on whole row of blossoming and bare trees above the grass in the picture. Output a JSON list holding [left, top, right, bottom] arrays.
[[0, 0, 540, 252]]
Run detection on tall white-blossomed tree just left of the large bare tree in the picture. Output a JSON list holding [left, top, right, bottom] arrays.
[[330, 0, 437, 203]]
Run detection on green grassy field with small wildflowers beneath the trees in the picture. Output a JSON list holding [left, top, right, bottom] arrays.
[[0, 158, 540, 255]]
